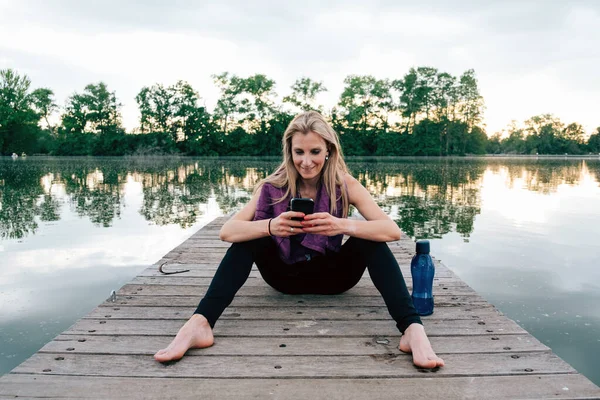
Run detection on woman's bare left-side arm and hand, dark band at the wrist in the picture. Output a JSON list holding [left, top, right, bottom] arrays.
[[219, 190, 304, 243]]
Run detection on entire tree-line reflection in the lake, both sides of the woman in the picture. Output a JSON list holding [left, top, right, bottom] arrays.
[[0, 158, 600, 239]]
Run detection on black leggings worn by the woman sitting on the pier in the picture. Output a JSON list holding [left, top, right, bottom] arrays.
[[194, 237, 421, 333]]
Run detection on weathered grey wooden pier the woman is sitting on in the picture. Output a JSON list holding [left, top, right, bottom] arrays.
[[0, 217, 600, 400]]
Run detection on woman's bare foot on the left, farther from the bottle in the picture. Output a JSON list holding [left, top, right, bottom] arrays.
[[154, 314, 214, 362]]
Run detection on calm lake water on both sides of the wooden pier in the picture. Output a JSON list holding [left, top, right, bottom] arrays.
[[0, 157, 600, 385]]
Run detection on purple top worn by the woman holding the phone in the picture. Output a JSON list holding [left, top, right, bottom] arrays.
[[254, 183, 344, 264]]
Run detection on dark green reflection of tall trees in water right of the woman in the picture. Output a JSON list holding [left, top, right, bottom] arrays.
[[351, 160, 485, 239]]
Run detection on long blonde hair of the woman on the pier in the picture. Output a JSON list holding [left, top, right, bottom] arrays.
[[255, 111, 349, 217]]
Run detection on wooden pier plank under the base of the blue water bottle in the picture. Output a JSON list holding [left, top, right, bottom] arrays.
[[85, 305, 501, 321]]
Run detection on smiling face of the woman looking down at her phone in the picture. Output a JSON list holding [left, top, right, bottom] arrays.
[[292, 131, 327, 184]]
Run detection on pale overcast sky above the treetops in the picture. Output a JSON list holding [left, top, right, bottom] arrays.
[[0, 0, 600, 134]]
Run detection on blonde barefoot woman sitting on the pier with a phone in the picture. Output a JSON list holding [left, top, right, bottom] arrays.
[[154, 111, 444, 368]]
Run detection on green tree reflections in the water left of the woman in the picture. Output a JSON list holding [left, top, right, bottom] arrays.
[[0, 158, 274, 239]]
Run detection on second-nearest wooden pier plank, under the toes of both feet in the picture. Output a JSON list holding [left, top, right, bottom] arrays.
[[13, 352, 576, 379]]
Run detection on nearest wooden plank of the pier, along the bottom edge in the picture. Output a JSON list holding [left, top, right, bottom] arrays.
[[0, 374, 600, 400]]
